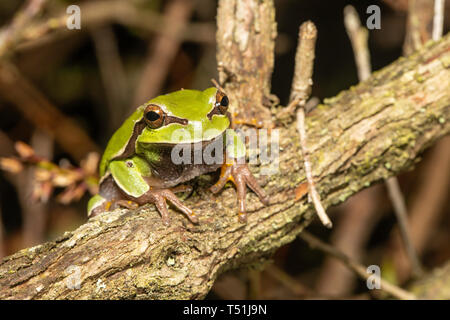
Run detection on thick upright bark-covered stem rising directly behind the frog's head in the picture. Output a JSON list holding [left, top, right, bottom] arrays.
[[216, 0, 277, 125]]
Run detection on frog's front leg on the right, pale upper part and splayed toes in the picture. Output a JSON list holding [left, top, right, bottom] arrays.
[[210, 130, 269, 222]]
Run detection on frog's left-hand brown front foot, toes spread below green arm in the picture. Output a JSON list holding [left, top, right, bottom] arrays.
[[136, 186, 198, 226]]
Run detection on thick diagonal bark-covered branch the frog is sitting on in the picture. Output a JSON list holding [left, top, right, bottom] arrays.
[[0, 31, 450, 299]]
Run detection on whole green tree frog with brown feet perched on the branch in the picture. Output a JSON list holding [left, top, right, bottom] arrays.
[[88, 87, 268, 225]]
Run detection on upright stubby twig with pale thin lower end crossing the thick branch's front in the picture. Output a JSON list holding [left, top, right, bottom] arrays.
[[288, 21, 333, 228]]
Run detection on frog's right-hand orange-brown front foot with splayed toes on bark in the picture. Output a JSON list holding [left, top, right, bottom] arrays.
[[210, 162, 269, 222]]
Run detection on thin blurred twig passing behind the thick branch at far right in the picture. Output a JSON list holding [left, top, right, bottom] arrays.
[[344, 5, 423, 276]]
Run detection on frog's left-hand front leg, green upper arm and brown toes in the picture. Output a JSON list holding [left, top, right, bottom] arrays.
[[109, 156, 198, 225]]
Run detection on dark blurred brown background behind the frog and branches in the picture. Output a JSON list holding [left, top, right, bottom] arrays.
[[0, 0, 450, 299]]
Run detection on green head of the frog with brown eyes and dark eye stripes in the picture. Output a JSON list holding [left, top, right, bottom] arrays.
[[138, 88, 231, 144]]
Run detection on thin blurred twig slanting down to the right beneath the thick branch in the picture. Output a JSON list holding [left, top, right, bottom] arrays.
[[300, 231, 417, 300]]
